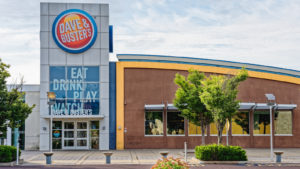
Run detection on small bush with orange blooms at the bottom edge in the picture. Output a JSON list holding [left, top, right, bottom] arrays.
[[151, 157, 189, 169]]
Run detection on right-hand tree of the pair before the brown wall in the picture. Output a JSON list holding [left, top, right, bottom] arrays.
[[200, 68, 248, 144]]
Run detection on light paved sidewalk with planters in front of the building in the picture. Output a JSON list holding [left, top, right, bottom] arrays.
[[21, 148, 300, 165]]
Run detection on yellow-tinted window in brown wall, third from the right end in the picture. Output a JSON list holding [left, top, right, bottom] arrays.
[[231, 112, 249, 135]]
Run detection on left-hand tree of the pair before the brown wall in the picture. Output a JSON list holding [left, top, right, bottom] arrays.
[[173, 69, 213, 144]]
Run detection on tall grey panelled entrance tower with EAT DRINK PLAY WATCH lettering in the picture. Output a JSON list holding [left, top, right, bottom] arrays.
[[39, 3, 109, 150]]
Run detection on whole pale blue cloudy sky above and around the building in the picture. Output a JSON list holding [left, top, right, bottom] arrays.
[[0, 0, 300, 84]]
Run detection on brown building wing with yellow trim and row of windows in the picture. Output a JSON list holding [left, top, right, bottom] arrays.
[[116, 54, 300, 149]]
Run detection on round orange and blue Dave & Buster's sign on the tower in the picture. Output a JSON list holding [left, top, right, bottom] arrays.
[[52, 9, 97, 53]]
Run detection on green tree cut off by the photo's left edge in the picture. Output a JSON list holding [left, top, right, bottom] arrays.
[[0, 59, 35, 138]]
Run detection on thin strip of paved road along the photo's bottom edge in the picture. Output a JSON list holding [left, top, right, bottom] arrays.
[[0, 164, 299, 169]]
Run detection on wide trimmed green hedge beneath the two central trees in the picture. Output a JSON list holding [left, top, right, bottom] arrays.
[[195, 144, 247, 161]]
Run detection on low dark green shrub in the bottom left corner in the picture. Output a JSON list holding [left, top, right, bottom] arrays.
[[0, 145, 21, 162]]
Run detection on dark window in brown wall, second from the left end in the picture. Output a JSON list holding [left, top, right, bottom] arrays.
[[167, 112, 184, 135]]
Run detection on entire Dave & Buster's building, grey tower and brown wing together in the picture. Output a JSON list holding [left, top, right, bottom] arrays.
[[6, 3, 300, 151]]
